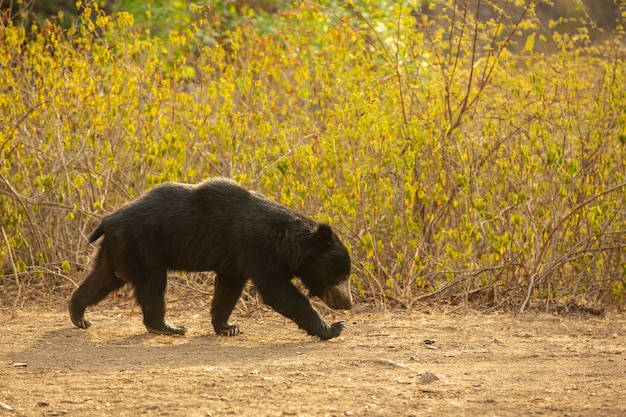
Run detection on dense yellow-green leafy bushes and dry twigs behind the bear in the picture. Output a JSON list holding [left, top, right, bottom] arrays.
[[0, 0, 626, 311]]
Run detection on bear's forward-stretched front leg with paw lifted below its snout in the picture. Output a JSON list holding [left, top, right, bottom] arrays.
[[256, 281, 345, 340]]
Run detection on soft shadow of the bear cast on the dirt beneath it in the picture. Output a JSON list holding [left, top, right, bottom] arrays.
[[4, 326, 328, 372]]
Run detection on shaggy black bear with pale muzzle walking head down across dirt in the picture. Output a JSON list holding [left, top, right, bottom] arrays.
[[69, 178, 352, 340]]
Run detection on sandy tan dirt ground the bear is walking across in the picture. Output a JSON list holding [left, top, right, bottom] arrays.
[[0, 305, 626, 417]]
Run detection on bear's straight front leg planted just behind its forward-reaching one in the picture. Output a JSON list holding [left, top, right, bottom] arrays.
[[211, 274, 247, 336]]
